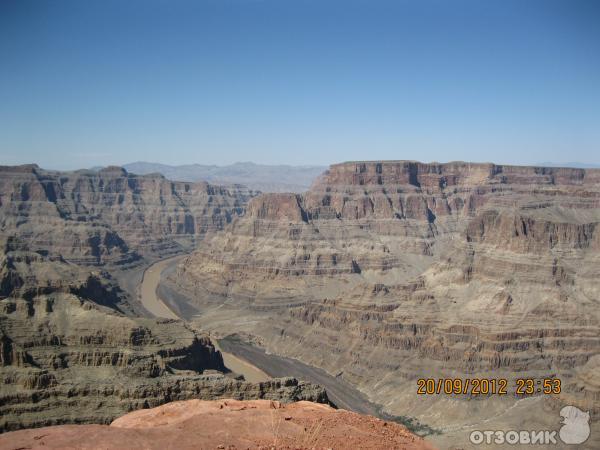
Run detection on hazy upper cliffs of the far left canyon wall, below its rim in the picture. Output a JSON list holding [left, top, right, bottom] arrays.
[[0, 165, 252, 265]]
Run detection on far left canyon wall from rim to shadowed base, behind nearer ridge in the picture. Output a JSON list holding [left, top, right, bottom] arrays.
[[0, 165, 254, 311]]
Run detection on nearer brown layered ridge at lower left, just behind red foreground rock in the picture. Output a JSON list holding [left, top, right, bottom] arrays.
[[0, 293, 328, 432]]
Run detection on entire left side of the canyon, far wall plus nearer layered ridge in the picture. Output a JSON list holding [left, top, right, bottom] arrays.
[[0, 165, 328, 431]]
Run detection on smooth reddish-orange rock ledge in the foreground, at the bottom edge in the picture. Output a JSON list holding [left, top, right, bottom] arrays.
[[0, 400, 433, 450]]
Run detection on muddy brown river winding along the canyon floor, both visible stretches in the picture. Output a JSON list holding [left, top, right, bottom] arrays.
[[138, 255, 271, 382]]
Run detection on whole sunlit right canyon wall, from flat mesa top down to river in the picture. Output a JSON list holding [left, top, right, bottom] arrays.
[[171, 161, 600, 444]]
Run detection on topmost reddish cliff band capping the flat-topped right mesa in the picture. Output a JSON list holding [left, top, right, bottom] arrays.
[[313, 161, 600, 189]]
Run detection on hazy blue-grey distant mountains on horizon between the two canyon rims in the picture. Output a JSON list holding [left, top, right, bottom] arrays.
[[123, 161, 327, 192]]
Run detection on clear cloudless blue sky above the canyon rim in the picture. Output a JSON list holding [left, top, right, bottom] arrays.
[[0, 0, 600, 169]]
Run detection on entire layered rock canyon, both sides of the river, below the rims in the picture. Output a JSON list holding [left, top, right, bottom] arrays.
[[0, 161, 600, 448]]
